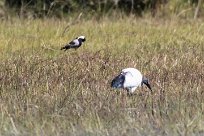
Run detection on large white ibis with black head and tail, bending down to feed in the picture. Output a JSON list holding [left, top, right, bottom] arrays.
[[111, 68, 152, 94]]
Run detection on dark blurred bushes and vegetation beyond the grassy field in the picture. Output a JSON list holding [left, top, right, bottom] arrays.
[[0, 0, 204, 19]]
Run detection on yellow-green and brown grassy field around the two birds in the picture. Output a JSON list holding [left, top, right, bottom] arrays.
[[0, 17, 204, 136]]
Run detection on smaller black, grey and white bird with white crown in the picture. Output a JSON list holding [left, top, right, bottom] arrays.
[[61, 36, 86, 51]]
